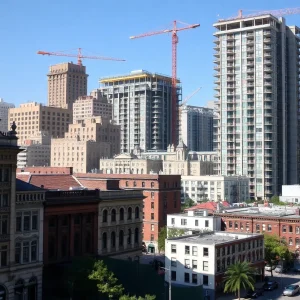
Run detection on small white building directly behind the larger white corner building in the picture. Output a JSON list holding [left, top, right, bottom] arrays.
[[167, 210, 222, 235]]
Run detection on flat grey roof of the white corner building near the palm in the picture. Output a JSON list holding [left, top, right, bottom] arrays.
[[168, 231, 263, 245]]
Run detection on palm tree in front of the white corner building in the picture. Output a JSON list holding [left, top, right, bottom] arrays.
[[224, 261, 255, 299]]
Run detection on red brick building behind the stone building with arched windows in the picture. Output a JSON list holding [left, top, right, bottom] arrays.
[[74, 173, 181, 252]]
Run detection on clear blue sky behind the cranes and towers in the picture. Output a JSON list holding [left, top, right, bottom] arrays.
[[0, 0, 300, 105]]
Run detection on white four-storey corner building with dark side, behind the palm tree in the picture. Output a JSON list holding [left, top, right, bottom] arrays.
[[165, 231, 265, 299]]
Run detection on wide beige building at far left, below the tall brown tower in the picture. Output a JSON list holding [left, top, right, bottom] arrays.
[[9, 102, 72, 145]]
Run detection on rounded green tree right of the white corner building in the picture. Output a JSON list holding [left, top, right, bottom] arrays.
[[264, 234, 291, 276]]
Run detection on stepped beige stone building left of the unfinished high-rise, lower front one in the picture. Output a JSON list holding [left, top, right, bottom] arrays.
[[51, 117, 120, 173]]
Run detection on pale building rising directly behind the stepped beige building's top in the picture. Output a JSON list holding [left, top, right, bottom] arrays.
[[73, 90, 112, 123]]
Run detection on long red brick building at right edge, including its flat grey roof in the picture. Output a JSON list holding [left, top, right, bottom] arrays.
[[214, 206, 300, 254]]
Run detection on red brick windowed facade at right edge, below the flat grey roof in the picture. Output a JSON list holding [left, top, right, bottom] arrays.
[[214, 209, 300, 253]]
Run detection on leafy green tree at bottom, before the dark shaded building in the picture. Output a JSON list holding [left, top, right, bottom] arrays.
[[88, 260, 124, 299]]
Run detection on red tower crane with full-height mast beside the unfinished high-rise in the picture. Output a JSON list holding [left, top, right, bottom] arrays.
[[130, 21, 200, 145]]
